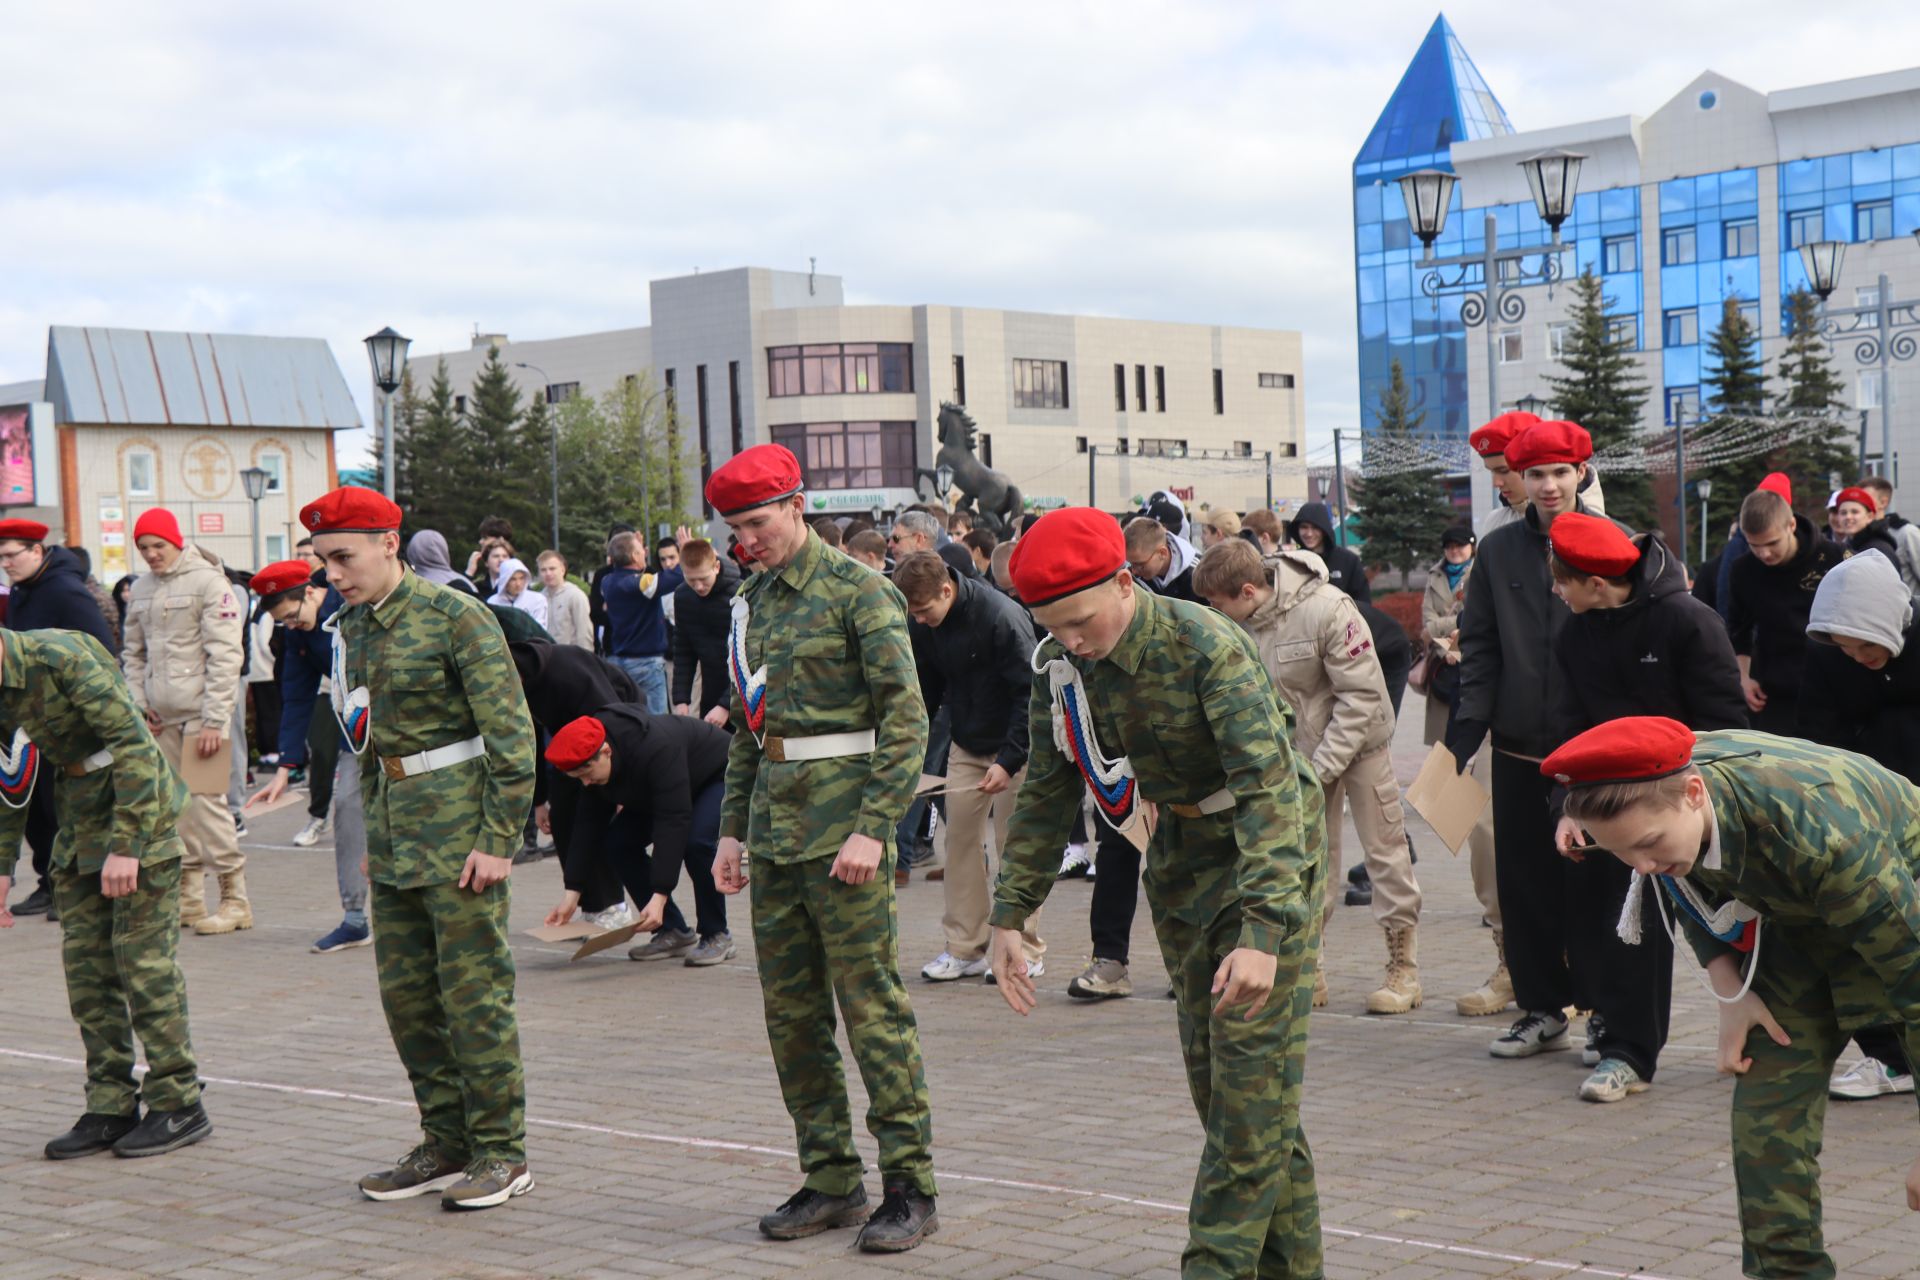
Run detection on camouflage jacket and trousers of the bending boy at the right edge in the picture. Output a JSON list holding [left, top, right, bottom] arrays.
[[1668, 731, 1920, 1278]]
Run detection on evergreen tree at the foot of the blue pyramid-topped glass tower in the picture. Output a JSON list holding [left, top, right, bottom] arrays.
[[1354, 361, 1455, 580]]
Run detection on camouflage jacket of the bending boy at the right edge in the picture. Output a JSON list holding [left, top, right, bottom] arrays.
[[1689, 729, 1920, 1054]]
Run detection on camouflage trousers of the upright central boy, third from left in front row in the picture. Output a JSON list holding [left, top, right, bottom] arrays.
[[749, 854, 935, 1196]]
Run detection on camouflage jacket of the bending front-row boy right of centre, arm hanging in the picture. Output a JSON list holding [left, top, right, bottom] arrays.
[[993, 591, 1325, 954]]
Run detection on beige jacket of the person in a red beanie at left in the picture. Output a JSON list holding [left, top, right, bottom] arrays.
[[121, 545, 246, 737]]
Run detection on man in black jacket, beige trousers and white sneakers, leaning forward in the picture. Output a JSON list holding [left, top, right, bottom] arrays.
[[893, 551, 1046, 983]]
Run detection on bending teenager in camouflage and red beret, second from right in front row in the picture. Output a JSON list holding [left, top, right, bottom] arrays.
[[991, 507, 1327, 1280]]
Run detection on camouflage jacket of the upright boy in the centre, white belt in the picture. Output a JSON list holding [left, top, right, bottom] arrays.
[[720, 533, 927, 862]]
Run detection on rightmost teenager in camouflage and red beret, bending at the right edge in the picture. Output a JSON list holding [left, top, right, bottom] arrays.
[[1540, 716, 1920, 1280]]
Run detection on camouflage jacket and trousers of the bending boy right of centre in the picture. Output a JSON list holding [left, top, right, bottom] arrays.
[[993, 591, 1327, 1280]]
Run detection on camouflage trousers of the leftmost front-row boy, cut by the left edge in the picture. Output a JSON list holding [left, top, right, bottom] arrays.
[[54, 855, 200, 1115]]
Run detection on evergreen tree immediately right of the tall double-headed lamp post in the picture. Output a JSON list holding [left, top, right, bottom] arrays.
[[1548, 269, 1657, 530]]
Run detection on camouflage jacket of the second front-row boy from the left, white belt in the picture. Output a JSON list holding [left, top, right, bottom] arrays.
[[336, 570, 534, 889]]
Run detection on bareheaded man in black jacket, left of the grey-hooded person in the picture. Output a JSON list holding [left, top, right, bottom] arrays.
[[1726, 489, 1847, 737]]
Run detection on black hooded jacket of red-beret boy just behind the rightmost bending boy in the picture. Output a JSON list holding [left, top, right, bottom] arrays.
[[1549, 533, 1747, 747]]
